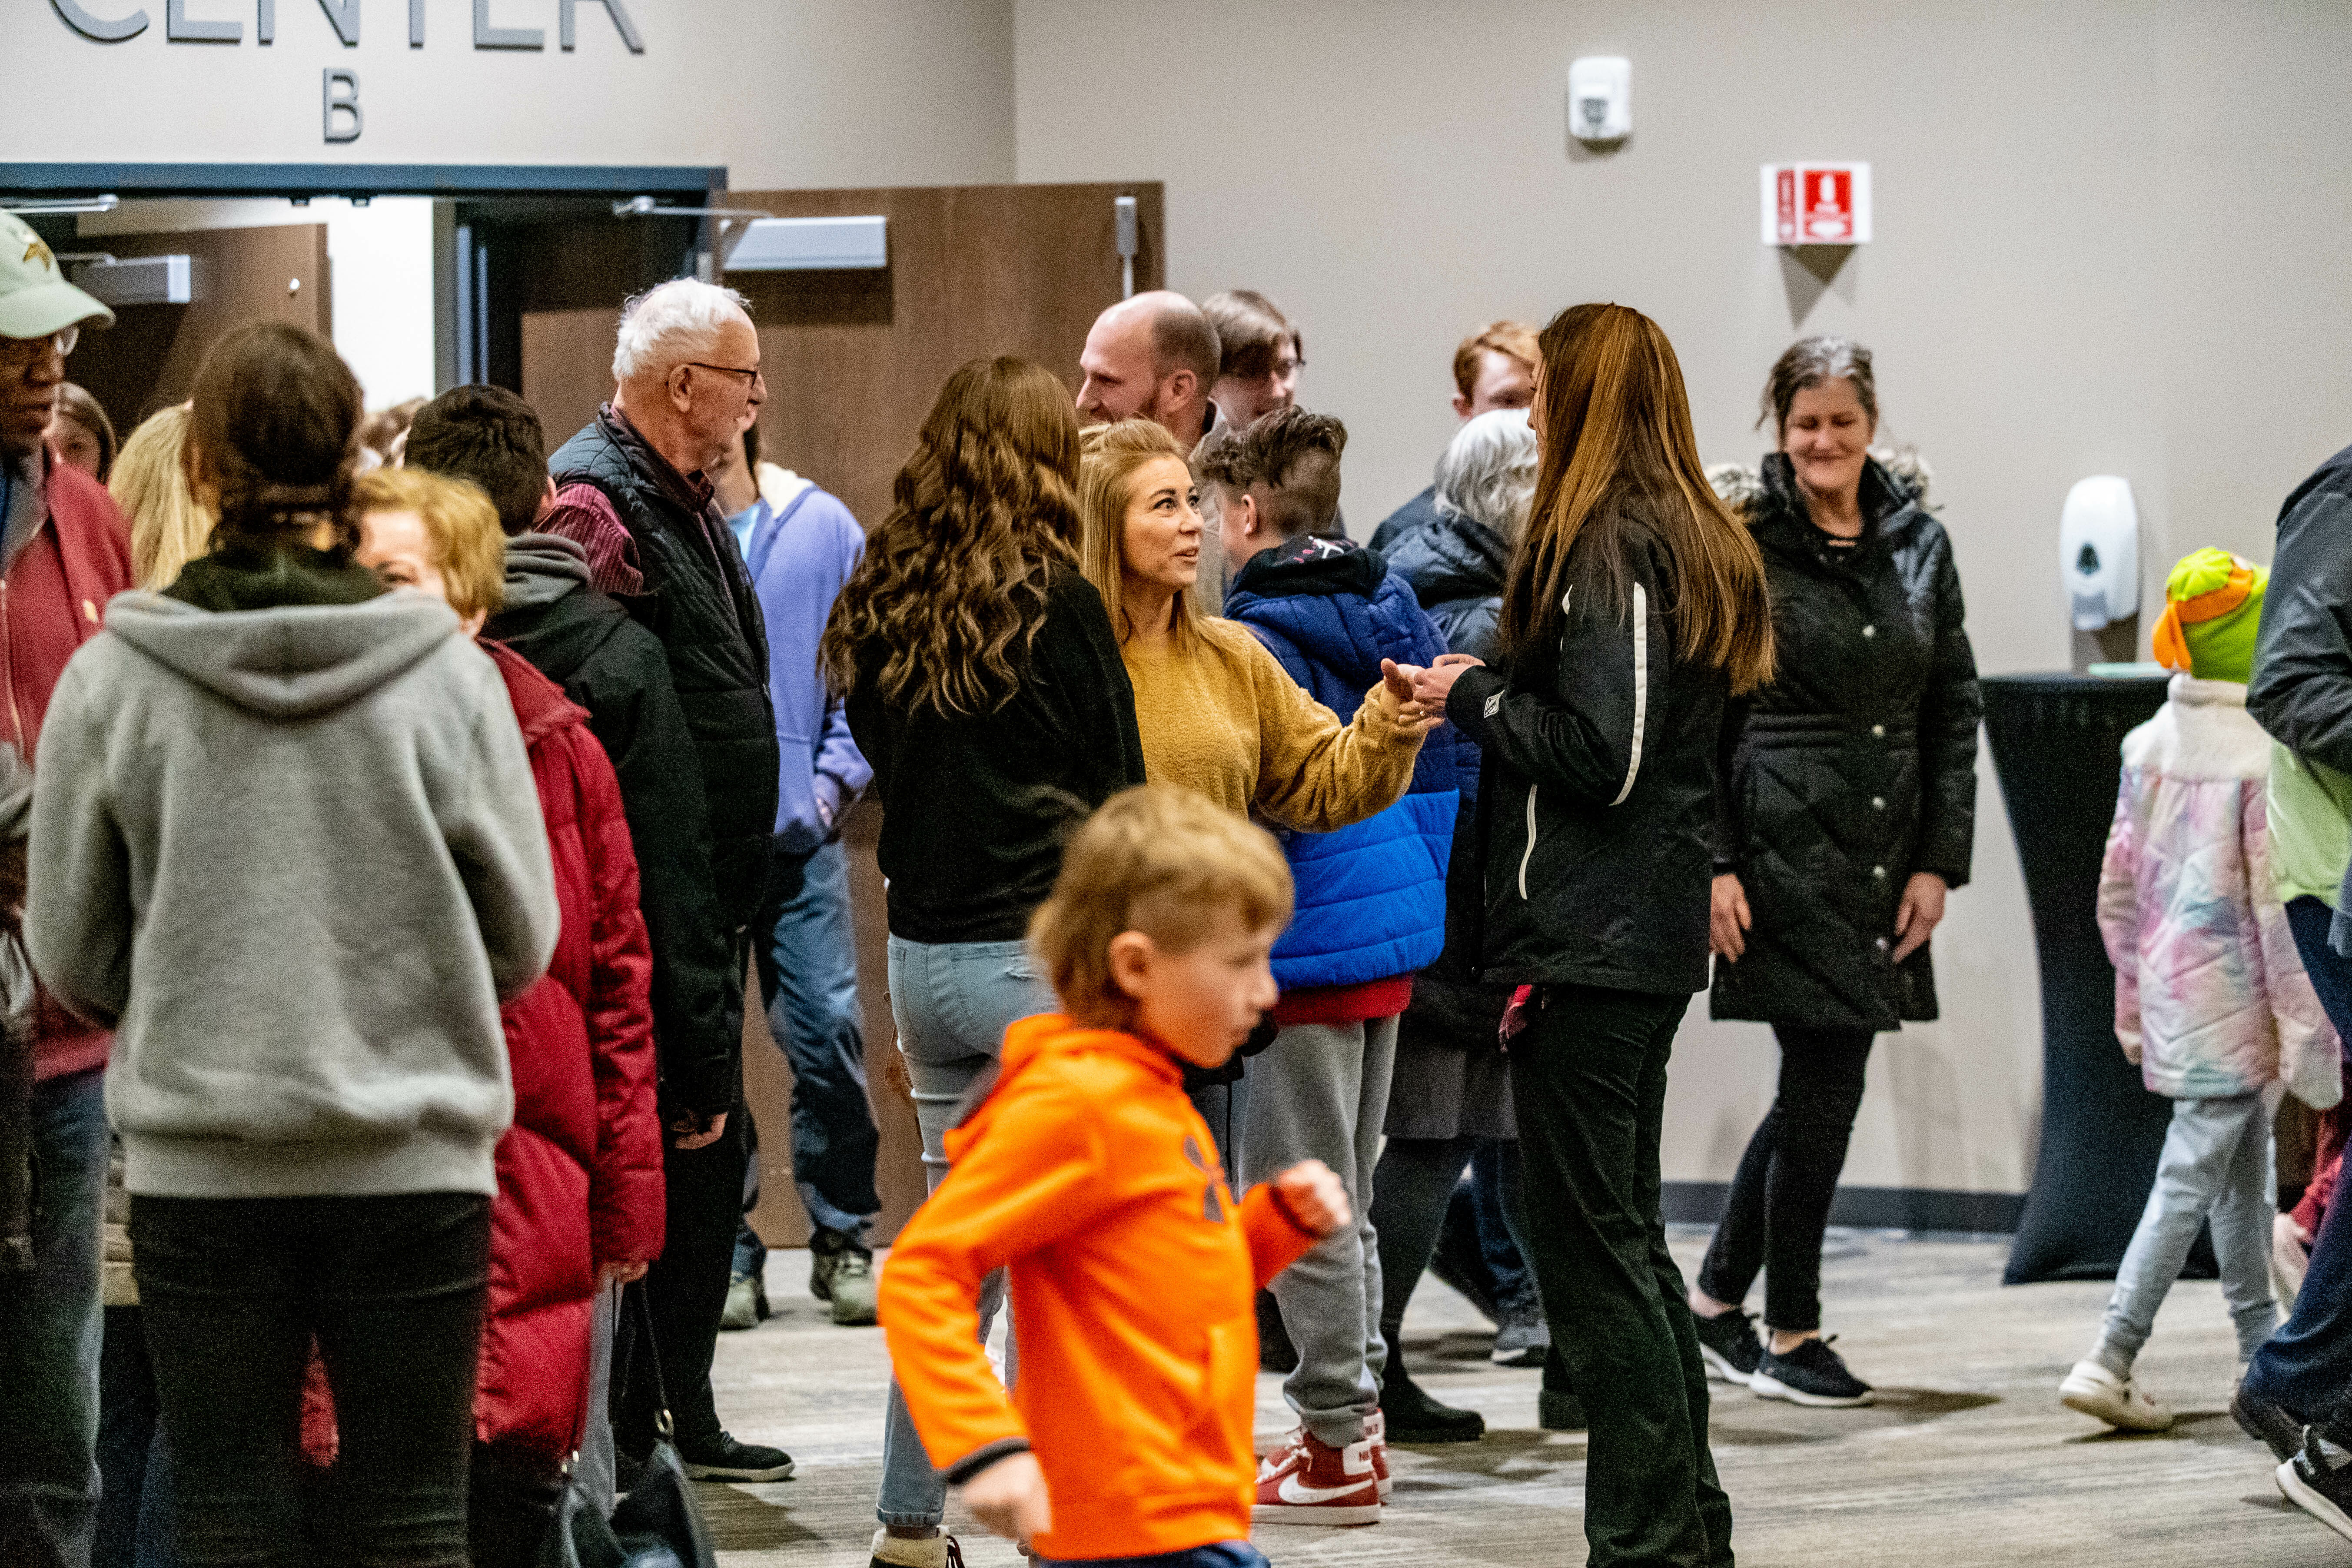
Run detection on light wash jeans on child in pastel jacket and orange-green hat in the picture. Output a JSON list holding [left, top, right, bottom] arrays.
[[2091, 1093, 2279, 1375]]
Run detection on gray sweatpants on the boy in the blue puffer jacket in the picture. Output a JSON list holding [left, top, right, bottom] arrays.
[[1239, 1016, 1397, 1448]]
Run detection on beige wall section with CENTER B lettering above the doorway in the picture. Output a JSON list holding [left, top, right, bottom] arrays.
[[0, 0, 1014, 190]]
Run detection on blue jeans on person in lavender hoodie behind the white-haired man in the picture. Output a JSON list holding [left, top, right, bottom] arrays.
[[753, 839, 882, 1246]]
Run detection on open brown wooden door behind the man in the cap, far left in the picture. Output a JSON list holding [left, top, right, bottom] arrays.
[[59, 223, 334, 437]]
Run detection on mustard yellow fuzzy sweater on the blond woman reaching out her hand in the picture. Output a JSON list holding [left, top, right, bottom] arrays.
[[1120, 618, 1421, 832]]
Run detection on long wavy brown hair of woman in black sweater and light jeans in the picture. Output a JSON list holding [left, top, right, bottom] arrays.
[[816, 357, 1080, 717]]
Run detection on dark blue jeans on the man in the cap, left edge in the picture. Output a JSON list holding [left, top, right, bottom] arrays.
[[0, 1067, 106, 1568]]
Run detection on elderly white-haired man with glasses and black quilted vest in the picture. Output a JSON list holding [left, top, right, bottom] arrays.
[[538, 277, 793, 1481]]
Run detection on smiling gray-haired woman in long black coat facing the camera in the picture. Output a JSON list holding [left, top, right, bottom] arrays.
[[1691, 339, 1983, 1406]]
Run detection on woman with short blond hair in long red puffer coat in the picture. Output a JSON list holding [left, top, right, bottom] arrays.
[[343, 470, 663, 1566]]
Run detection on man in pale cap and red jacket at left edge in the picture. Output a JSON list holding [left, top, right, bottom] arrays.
[[0, 212, 132, 1568]]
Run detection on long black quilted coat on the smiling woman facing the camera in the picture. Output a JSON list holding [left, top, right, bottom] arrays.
[[1710, 454, 1983, 1030]]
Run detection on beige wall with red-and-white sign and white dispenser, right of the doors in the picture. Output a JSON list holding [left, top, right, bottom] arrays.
[[1016, 0, 2352, 1192]]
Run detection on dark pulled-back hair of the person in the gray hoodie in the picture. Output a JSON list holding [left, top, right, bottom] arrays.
[[186, 322, 362, 557]]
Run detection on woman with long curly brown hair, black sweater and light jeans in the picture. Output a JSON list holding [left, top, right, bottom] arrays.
[[818, 357, 1143, 1568]]
